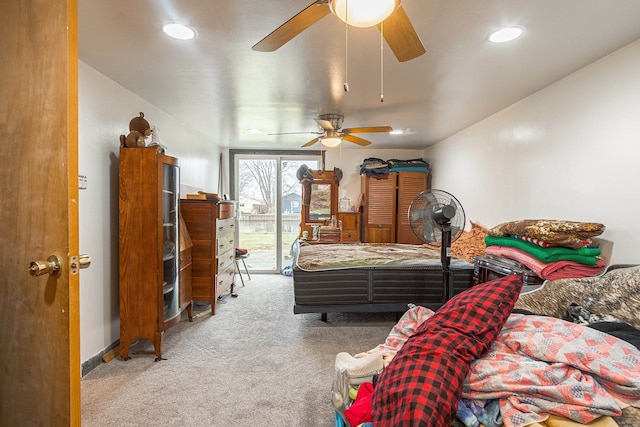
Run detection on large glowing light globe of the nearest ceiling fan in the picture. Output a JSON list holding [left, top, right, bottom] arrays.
[[330, 0, 400, 28]]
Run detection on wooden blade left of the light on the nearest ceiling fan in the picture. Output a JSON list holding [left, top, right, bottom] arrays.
[[251, 0, 331, 52]]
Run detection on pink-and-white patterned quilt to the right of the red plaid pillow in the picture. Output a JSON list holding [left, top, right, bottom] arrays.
[[462, 314, 640, 427]]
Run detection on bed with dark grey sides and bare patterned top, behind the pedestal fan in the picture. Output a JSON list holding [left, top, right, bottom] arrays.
[[293, 243, 473, 320]]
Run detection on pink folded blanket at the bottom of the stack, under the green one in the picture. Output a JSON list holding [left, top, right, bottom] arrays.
[[486, 246, 605, 280]]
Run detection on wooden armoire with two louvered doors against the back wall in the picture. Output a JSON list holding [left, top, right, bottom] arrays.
[[361, 171, 431, 244]]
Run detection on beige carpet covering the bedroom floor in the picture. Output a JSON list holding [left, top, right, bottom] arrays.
[[82, 275, 396, 427]]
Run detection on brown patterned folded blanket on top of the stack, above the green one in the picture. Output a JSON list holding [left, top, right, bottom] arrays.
[[488, 219, 605, 249]]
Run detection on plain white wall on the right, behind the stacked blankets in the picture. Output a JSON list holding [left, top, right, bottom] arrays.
[[424, 41, 640, 263]]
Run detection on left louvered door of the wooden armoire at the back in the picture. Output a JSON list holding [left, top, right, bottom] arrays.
[[362, 172, 397, 243]]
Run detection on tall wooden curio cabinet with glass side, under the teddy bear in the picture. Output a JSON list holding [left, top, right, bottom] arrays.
[[118, 148, 191, 360]]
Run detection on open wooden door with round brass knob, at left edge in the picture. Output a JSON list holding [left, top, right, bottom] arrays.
[[0, 0, 80, 426]]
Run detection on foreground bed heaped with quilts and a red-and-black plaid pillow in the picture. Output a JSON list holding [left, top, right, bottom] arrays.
[[332, 265, 640, 427]]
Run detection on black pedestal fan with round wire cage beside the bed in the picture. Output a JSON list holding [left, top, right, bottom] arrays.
[[409, 190, 466, 300]]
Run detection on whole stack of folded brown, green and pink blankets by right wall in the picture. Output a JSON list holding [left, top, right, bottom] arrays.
[[485, 219, 606, 280]]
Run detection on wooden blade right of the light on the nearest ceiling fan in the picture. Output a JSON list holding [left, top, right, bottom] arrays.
[[377, 6, 426, 62]]
